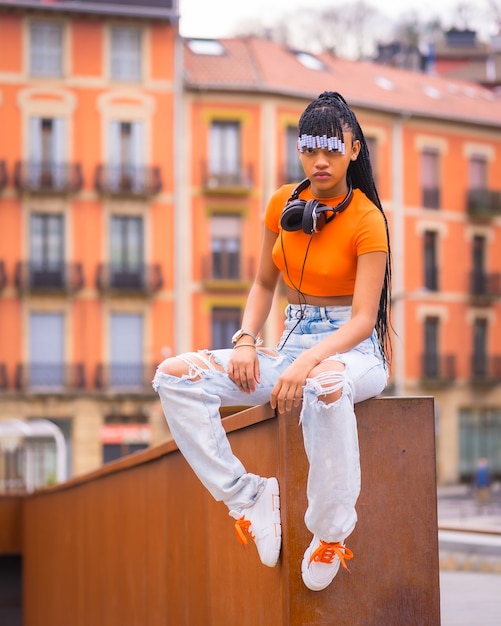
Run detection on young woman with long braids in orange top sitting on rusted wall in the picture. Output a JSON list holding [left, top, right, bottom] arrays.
[[154, 92, 391, 591]]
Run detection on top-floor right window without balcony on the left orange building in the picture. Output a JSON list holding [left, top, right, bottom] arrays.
[[110, 26, 141, 81]]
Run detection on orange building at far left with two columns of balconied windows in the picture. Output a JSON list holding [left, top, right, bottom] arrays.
[[0, 0, 179, 487]]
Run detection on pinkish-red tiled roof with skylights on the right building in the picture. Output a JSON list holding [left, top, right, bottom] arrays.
[[184, 38, 501, 128]]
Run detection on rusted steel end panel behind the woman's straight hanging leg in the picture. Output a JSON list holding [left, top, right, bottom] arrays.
[[281, 398, 440, 626]]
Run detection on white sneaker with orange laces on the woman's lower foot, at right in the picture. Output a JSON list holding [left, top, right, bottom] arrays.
[[301, 536, 353, 591]]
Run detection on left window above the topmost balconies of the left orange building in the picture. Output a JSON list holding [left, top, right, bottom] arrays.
[[28, 117, 66, 189]]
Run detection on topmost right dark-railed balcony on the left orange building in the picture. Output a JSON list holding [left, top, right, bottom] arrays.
[[95, 165, 162, 197]]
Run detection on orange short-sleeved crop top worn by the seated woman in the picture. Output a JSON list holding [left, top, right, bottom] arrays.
[[264, 185, 388, 296]]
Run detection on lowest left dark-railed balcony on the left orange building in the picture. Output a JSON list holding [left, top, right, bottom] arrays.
[[14, 363, 86, 393]]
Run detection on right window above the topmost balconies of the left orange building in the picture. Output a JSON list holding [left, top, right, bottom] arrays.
[[108, 120, 144, 191]]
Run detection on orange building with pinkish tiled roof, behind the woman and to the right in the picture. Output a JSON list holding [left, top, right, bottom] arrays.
[[180, 39, 501, 483]]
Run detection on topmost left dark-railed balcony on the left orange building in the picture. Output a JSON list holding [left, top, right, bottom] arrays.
[[14, 161, 83, 194]]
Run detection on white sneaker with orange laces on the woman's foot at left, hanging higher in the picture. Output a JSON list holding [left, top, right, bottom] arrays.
[[230, 478, 282, 567]]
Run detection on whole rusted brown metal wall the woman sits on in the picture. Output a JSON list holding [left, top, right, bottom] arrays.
[[23, 398, 440, 626]]
